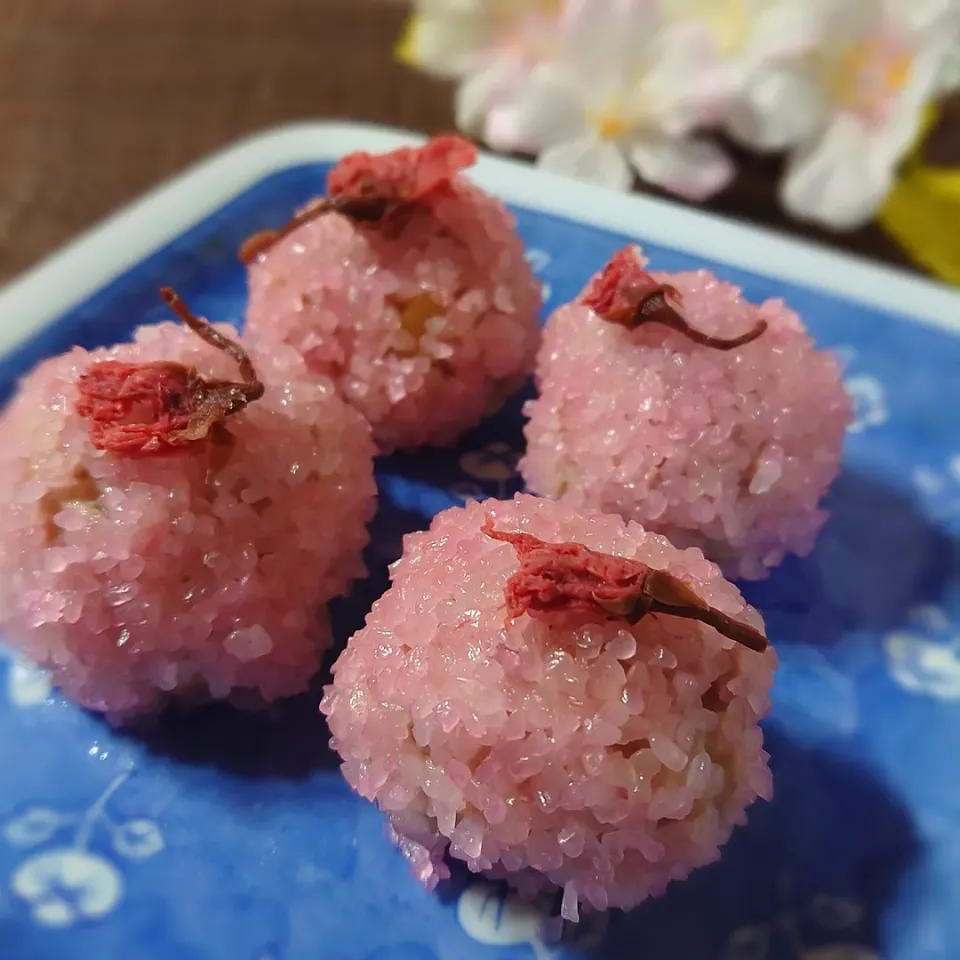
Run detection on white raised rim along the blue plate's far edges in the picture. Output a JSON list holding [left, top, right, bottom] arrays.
[[0, 121, 960, 364]]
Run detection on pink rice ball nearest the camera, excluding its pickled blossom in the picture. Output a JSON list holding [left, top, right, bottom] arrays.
[[321, 495, 776, 920]]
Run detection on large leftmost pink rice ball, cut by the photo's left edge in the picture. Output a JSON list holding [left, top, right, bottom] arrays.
[[0, 300, 376, 719]]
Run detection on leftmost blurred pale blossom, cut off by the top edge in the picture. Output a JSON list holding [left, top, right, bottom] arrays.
[[398, 0, 563, 149]]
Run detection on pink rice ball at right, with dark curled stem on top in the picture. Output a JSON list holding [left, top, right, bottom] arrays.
[[520, 247, 852, 579]]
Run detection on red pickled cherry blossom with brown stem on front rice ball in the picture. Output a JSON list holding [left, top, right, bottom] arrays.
[[482, 516, 767, 652]]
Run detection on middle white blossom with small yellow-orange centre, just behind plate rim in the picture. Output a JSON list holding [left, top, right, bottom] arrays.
[[485, 0, 733, 200]]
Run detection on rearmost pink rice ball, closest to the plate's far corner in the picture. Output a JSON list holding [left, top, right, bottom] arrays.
[[246, 137, 542, 453]]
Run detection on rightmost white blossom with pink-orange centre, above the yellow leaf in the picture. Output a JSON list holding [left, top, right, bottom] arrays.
[[753, 0, 958, 229]]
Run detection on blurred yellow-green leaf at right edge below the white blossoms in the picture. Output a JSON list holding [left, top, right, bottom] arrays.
[[879, 108, 960, 285]]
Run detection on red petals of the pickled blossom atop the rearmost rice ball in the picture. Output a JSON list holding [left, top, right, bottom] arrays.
[[327, 136, 477, 204]]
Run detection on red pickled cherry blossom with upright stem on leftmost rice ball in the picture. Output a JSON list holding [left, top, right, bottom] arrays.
[[77, 288, 263, 455]]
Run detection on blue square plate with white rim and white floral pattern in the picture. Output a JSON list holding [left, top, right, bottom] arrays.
[[0, 124, 960, 960]]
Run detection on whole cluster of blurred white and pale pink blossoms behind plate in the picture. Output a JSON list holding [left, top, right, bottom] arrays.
[[400, 0, 960, 229]]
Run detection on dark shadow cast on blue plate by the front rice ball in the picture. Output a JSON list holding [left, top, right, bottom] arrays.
[[587, 724, 921, 960]]
